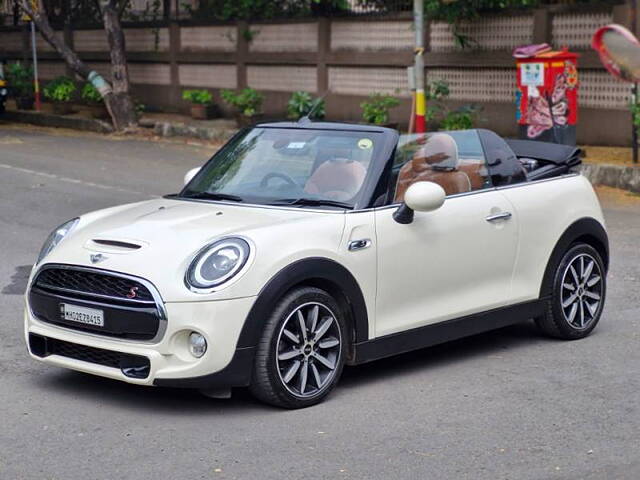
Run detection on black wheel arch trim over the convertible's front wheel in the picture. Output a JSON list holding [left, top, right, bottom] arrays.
[[237, 257, 369, 348]]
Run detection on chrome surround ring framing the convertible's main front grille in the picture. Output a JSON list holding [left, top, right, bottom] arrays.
[[27, 263, 169, 344]]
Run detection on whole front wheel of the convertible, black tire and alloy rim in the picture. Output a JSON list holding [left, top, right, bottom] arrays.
[[249, 287, 348, 408]]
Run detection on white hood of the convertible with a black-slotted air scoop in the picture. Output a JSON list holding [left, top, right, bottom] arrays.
[[39, 198, 344, 301]]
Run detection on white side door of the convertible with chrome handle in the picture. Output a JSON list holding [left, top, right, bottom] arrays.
[[375, 132, 518, 337]]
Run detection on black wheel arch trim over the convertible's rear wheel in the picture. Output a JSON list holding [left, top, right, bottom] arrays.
[[540, 217, 609, 298]]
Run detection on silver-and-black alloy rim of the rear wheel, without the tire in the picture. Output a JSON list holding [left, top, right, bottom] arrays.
[[560, 253, 603, 330]]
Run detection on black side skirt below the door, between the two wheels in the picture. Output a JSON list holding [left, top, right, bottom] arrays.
[[349, 298, 547, 365]]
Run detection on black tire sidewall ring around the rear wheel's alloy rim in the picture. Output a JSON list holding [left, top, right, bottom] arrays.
[[551, 243, 607, 339]]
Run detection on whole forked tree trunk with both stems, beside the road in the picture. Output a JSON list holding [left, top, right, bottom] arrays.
[[19, 0, 137, 131]]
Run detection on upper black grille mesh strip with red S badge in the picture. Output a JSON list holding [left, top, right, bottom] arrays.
[[35, 268, 153, 301]]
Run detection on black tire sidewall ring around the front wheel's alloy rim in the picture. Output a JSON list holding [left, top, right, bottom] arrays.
[[266, 287, 349, 408]]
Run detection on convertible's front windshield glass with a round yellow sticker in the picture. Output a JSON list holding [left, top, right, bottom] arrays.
[[180, 127, 381, 208]]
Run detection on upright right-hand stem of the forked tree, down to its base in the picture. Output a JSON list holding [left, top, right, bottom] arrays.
[[100, 0, 138, 130]]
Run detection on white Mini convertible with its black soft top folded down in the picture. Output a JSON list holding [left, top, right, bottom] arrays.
[[24, 121, 609, 408]]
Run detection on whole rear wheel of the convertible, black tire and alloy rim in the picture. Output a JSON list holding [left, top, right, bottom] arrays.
[[535, 243, 607, 340]]
